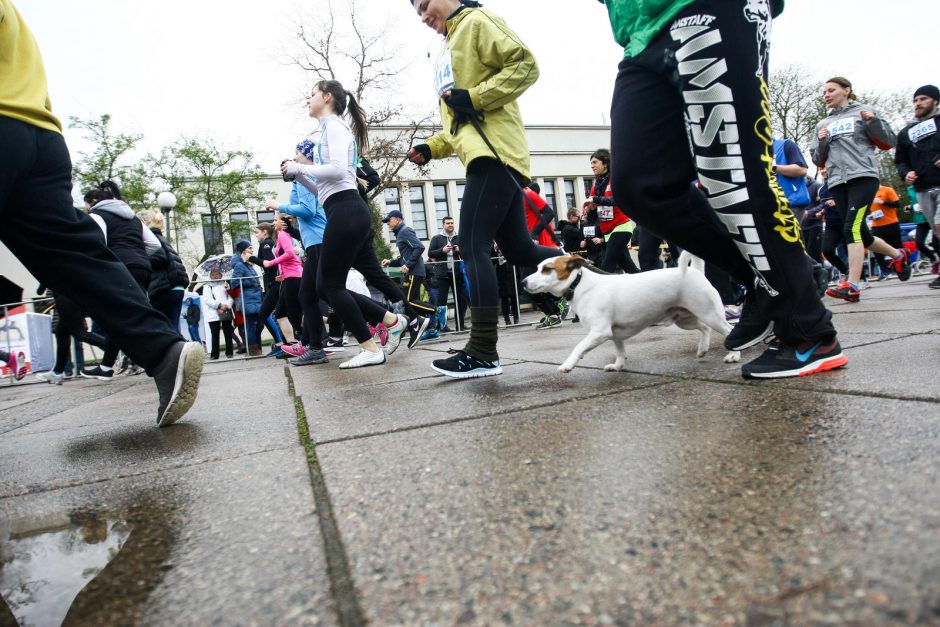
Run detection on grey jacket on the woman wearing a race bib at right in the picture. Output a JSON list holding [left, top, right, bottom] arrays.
[[809, 102, 897, 188]]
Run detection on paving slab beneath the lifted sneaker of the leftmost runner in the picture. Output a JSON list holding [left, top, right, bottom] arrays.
[[0, 360, 297, 497]]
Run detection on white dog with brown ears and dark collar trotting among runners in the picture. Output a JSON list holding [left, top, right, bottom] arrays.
[[522, 252, 741, 372]]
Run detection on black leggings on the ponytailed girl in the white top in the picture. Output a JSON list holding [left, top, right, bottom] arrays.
[[317, 190, 405, 344]]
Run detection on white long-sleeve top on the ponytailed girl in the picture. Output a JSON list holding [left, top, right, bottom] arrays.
[[298, 115, 357, 204]]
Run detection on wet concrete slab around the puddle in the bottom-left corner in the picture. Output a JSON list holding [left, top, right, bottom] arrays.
[[0, 447, 335, 625]]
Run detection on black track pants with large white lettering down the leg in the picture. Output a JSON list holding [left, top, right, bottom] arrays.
[[611, 0, 835, 343]]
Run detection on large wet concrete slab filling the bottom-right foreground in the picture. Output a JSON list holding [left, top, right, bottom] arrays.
[[318, 381, 940, 625]]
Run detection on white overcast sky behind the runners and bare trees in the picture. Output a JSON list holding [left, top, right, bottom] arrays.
[[20, 0, 940, 172]]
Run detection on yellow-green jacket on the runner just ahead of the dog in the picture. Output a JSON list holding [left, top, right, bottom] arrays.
[[427, 8, 539, 181]]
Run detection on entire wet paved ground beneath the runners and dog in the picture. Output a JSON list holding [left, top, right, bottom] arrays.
[[0, 275, 940, 625]]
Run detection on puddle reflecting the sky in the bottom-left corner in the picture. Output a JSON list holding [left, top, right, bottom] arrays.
[[0, 503, 176, 627]]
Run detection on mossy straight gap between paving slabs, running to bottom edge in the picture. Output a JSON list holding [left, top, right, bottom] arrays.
[[284, 367, 366, 627]]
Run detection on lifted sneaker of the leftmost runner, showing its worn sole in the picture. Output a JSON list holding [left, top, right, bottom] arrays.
[[153, 342, 206, 427]]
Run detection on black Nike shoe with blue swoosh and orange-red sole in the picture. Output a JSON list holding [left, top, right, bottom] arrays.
[[741, 338, 849, 379]]
